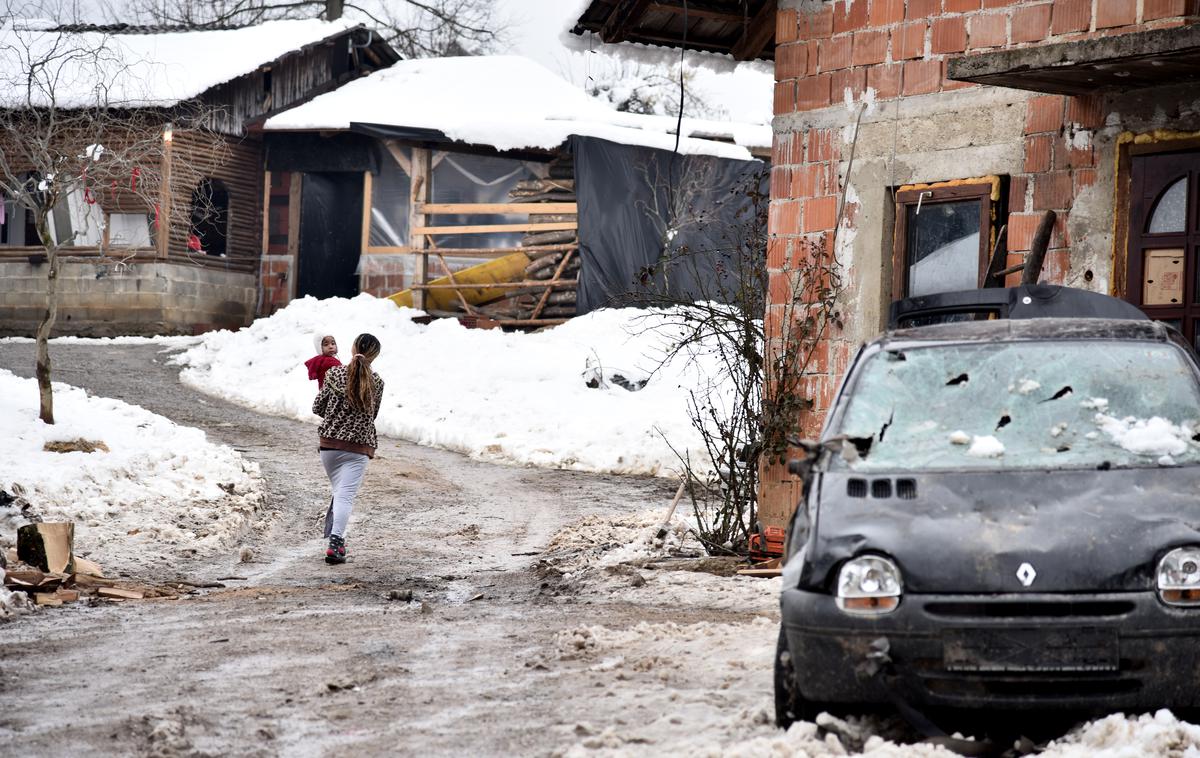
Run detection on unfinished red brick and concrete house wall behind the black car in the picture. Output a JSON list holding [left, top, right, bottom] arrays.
[[760, 0, 1200, 523]]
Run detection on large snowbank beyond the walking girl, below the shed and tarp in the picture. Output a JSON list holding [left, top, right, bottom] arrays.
[[173, 295, 712, 475]]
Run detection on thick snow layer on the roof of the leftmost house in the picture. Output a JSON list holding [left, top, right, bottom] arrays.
[[0, 19, 355, 108]]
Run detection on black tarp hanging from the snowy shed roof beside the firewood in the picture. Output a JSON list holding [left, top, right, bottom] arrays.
[[570, 137, 768, 314]]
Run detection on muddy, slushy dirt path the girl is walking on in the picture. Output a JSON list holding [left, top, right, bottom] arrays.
[[0, 344, 774, 756]]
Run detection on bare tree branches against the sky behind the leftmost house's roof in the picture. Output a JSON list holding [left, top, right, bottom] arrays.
[[107, 0, 500, 58]]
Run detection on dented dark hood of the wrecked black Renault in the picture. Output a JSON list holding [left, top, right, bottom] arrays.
[[800, 467, 1200, 592]]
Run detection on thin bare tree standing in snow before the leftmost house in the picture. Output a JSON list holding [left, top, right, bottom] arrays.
[[0, 13, 213, 423]]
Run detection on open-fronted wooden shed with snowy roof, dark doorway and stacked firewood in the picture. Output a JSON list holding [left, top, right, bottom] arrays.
[[263, 56, 770, 326]]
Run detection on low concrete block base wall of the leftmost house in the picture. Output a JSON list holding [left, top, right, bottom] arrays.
[[0, 260, 258, 337]]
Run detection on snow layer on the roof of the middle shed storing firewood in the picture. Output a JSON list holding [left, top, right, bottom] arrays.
[[264, 55, 772, 158]]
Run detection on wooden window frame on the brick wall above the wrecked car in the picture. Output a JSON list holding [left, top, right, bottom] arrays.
[[892, 182, 1003, 300]]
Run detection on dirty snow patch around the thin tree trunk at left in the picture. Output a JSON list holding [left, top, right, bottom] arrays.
[[0, 369, 263, 571]]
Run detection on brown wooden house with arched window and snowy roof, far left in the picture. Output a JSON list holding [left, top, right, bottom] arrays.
[[0, 20, 397, 336]]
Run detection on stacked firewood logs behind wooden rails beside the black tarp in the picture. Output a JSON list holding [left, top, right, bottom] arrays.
[[478, 157, 581, 320]]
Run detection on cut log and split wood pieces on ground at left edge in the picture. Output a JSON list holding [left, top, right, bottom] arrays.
[[0, 522, 166, 606]]
